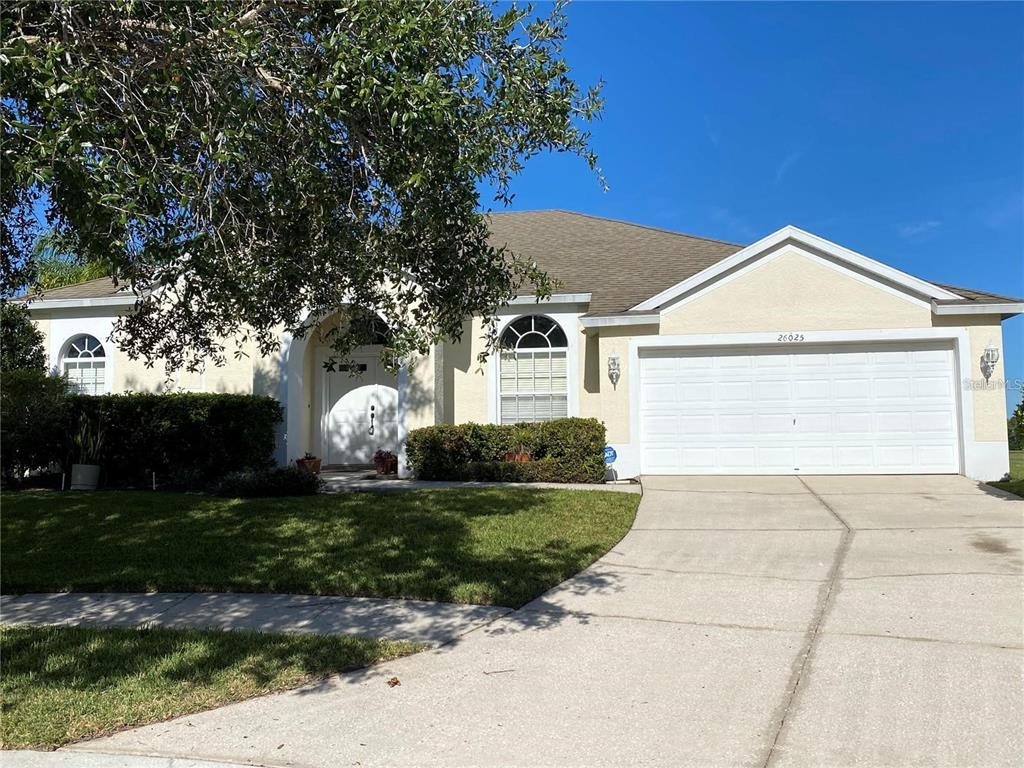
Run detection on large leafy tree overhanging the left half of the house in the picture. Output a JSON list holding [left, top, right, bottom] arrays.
[[0, 0, 600, 368]]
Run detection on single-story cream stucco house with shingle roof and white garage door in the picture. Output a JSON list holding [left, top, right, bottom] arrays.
[[24, 211, 1024, 479]]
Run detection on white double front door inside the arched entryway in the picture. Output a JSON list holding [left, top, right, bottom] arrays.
[[318, 350, 398, 465]]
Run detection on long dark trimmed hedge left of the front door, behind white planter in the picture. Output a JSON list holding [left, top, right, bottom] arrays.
[[61, 392, 283, 488]]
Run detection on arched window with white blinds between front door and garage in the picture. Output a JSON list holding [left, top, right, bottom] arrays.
[[499, 314, 568, 424]]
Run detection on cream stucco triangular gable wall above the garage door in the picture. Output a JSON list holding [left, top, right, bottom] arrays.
[[662, 248, 931, 335]]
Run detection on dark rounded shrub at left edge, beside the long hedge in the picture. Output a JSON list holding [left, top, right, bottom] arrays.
[[0, 369, 68, 478]]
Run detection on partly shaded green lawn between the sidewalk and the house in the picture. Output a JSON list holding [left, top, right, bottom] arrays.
[[0, 487, 639, 607]]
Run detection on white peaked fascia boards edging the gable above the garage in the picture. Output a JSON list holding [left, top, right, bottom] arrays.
[[630, 225, 963, 311]]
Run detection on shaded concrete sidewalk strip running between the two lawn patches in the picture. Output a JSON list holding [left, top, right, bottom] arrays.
[[0, 592, 511, 645]]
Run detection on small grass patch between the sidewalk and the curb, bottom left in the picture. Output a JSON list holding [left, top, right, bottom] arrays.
[[0, 627, 419, 750]]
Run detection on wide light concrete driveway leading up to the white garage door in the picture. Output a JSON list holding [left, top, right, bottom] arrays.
[[68, 476, 1024, 768]]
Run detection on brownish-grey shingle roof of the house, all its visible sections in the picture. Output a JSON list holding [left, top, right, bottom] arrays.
[[19, 210, 1022, 314]]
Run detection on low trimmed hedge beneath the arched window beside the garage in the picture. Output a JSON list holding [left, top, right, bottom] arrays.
[[406, 419, 605, 482]]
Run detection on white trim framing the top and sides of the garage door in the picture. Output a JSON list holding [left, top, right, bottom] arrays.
[[616, 328, 974, 477]]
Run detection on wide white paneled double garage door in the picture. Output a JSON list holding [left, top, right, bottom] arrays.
[[639, 344, 959, 474]]
